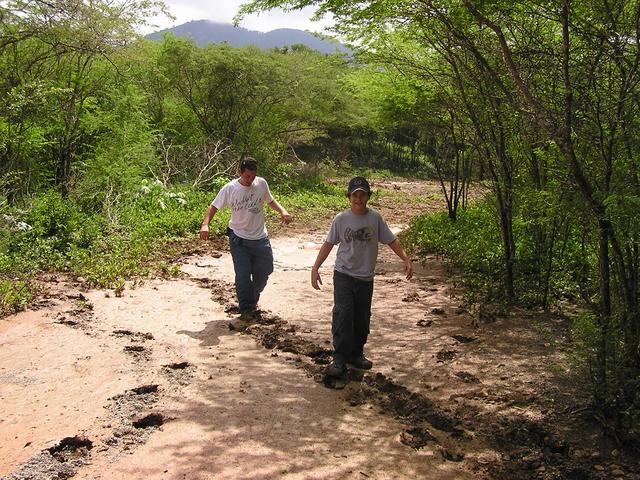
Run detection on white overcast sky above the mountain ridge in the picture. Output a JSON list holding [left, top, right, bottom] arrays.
[[144, 0, 330, 33]]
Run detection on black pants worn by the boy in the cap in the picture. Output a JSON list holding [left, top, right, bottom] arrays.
[[331, 270, 373, 363]]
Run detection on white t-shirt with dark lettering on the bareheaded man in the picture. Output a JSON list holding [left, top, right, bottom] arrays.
[[211, 177, 273, 240]]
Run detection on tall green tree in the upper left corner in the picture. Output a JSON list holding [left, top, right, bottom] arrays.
[[0, 0, 164, 201]]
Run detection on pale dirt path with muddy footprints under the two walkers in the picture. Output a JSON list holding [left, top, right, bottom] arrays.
[[0, 182, 640, 480]]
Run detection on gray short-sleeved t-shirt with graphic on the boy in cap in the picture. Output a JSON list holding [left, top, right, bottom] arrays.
[[326, 208, 396, 280]]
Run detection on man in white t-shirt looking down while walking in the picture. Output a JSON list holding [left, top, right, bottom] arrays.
[[200, 157, 292, 320]]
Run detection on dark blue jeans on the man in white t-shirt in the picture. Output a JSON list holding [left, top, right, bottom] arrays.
[[227, 228, 273, 312]]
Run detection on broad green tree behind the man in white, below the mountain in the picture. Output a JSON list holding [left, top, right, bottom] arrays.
[[148, 36, 359, 176]]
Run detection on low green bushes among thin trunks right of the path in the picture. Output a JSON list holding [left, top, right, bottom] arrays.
[[405, 197, 597, 308]]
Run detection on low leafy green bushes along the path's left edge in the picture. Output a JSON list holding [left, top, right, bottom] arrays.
[[0, 182, 220, 294]]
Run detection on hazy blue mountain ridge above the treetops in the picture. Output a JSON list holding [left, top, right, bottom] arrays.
[[146, 20, 351, 54]]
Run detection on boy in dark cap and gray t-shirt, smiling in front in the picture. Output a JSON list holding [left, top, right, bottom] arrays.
[[311, 177, 413, 378]]
